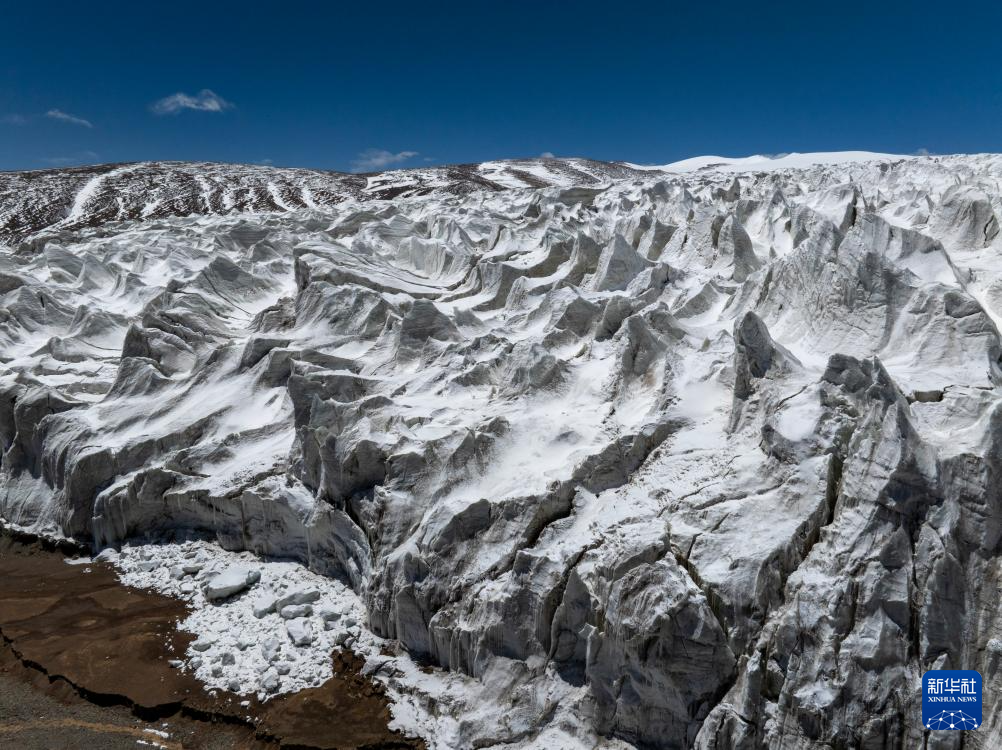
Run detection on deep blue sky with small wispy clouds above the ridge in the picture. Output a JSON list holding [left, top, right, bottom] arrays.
[[0, 0, 1002, 171]]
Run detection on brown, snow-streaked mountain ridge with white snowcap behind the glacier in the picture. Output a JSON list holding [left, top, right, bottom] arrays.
[[0, 152, 905, 244]]
